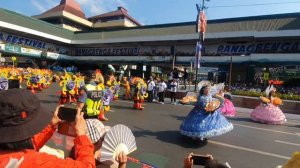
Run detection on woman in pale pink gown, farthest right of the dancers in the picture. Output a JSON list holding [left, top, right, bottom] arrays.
[[250, 86, 286, 124]]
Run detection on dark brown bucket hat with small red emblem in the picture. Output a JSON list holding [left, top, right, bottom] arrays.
[[0, 89, 52, 143]]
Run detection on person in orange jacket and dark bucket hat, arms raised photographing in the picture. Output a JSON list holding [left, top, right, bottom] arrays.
[[0, 89, 95, 167]]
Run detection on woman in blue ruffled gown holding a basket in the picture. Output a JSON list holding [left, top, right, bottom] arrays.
[[180, 85, 233, 140]]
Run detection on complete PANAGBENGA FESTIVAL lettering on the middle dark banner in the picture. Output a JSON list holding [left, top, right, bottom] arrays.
[[75, 47, 140, 56]]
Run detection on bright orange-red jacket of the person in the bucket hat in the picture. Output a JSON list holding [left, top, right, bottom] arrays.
[[0, 125, 95, 168]]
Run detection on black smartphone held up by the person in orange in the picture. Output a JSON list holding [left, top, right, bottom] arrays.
[[57, 104, 77, 122]]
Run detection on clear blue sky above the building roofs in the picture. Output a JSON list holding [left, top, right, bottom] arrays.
[[0, 0, 300, 25]]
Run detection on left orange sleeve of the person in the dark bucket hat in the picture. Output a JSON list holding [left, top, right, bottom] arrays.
[[32, 125, 56, 151]]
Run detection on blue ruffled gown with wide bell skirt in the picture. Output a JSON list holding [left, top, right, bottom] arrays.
[[180, 95, 233, 139]]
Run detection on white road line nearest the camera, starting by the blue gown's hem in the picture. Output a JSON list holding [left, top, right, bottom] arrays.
[[208, 140, 290, 160]]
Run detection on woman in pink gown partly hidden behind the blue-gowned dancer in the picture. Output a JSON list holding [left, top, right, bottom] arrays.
[[221, 86, 236, 117]]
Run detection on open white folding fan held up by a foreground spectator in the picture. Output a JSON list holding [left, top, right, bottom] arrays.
[[96, 124, 137, 163]]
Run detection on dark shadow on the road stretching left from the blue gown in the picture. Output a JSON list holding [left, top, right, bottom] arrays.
[[133, 129, 207, 148]]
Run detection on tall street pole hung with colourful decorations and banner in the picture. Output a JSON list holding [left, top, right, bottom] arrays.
[[195, 0, 209, 91]]
